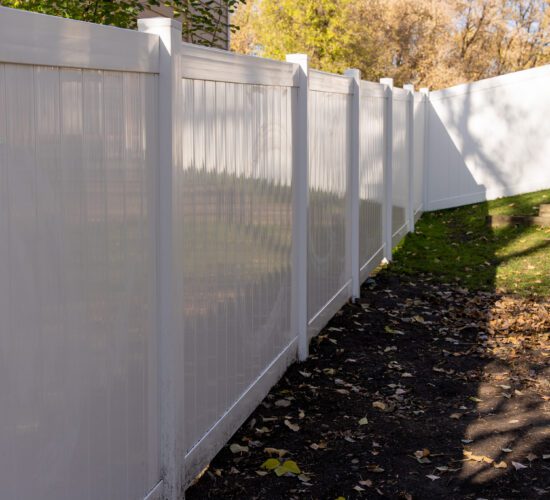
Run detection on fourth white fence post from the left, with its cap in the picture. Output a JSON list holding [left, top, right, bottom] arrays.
[[380, 78, 393, 261]]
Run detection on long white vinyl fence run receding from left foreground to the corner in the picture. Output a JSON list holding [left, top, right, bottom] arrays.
[[0, 8, 548, 500]]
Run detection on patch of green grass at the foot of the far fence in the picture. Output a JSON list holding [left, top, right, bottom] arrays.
[[387, 190, 550, 297]]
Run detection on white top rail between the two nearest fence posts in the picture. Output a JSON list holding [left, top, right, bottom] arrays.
[[181, 43, 299, 87]]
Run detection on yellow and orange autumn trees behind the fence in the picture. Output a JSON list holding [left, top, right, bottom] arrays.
[[232, 0, 550, 89]]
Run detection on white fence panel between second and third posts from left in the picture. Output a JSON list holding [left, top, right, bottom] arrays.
[[308, 70, 353, 336]]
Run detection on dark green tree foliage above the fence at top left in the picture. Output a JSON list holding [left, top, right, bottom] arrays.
[[0, 0, 244, 45]]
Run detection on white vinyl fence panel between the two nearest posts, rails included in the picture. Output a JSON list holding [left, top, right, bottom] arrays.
[[174, 45, 297, 480]]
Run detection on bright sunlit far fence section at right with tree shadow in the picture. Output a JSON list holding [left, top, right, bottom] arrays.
[[426, 65, 550, 210]]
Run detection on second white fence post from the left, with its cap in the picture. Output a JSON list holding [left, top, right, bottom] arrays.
[[286, 54, 309, 361]]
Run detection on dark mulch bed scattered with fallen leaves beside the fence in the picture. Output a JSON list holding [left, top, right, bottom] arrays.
[[187, 271, 550, 499]]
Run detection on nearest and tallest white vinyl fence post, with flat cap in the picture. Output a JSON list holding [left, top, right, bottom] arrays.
[[138, 18, 185, 500]]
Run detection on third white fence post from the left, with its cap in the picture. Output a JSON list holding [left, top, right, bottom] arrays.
[[344, 69, 361, 299]]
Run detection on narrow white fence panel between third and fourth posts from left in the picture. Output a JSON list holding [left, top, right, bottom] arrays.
[[359, 82, 387, 281]]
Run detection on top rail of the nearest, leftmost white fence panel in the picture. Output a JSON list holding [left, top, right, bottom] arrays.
[[0, 7, 159, 73]]
